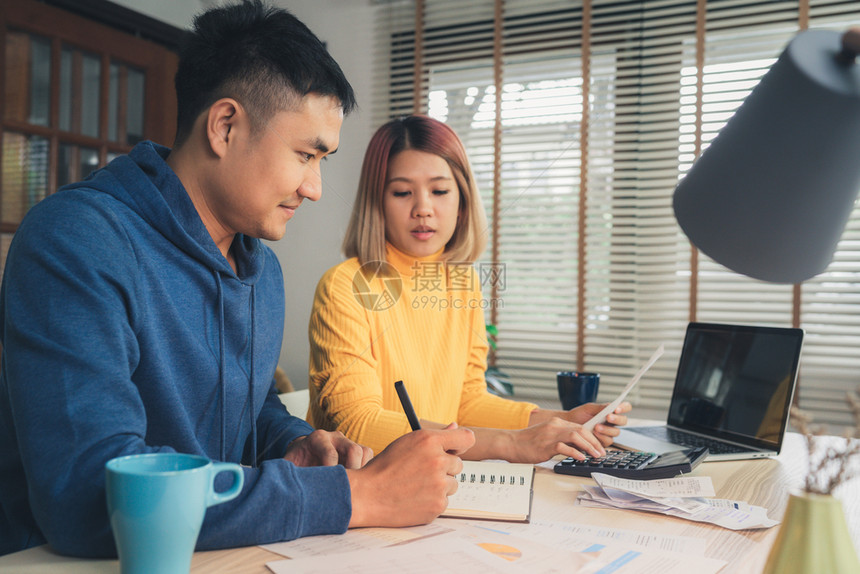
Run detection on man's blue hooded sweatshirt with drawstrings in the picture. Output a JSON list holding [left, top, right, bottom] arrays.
[[0, 142, 351, 556]]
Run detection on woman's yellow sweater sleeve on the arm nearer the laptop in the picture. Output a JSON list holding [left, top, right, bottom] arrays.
[[457, 280, 537, 429]]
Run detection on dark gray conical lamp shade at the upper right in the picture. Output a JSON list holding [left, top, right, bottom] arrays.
[[674, 30, 860, 283]]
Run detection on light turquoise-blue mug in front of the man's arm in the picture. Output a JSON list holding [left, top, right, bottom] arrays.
[[105, 452, 245, 574]]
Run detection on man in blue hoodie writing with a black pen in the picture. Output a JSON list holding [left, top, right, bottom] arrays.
[[0, 0, 474, 556]]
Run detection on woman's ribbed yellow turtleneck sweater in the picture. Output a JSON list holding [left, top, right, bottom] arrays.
[[308, 245, 537, 453]]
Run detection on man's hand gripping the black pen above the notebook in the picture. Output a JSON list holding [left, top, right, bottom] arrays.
[[347, 423, 475, 528]]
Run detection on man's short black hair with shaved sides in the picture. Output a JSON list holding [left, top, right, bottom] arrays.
[[175, 0, 355, 145]]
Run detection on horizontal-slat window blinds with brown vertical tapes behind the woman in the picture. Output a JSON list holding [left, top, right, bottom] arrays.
[[379, 0, 860, 423]]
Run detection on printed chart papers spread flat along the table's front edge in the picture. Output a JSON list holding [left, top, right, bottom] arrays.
[[265, 518, 726, 574]]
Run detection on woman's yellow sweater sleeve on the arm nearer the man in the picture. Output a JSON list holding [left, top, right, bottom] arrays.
[[308, 259, 411, 453]]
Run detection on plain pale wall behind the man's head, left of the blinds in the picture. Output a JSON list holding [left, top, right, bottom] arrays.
[[107, 0, 376, 388]]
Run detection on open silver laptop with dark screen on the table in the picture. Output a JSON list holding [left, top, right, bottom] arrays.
[[615, 323, 803, 461]]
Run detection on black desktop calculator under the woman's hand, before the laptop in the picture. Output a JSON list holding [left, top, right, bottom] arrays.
[[554, 446, 708, 480]]
